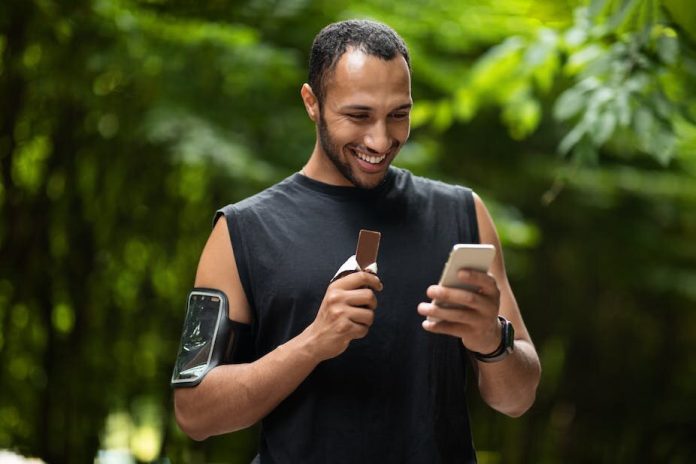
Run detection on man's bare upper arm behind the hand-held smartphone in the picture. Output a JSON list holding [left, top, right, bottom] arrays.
[[474, 194, 531, 341]]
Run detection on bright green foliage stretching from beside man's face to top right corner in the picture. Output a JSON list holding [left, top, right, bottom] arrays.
[[414, 0, 696, 165]]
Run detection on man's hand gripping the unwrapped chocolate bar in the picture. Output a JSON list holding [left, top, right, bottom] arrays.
[[305, 272, 383, 361]]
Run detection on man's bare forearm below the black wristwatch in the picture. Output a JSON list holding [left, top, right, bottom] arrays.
[[474, 339, 541, 417]]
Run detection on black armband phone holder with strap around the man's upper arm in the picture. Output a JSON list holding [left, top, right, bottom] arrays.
[[171, 288, 253, 387]]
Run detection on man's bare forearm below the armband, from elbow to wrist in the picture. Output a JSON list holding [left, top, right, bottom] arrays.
[[174, 326, 319, 440]]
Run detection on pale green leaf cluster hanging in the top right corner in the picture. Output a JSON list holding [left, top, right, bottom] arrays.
[[554, 1, 696, 165]]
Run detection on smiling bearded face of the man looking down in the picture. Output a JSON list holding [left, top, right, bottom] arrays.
[[318, 49, 412, 188]]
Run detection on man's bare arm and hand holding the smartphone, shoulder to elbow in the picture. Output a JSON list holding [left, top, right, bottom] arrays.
[[418, 192, 541, 417]]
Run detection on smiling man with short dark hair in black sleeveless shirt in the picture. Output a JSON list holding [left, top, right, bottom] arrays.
[[175, 21, 540, 464]]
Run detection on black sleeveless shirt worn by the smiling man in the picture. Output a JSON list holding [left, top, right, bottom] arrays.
[[216, 167, 478, 464]]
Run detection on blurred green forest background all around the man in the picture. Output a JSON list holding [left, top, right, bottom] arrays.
[[0, 0, 696, 464]]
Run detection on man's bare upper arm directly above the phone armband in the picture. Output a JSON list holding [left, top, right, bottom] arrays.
[[195, 216, 252, 324]]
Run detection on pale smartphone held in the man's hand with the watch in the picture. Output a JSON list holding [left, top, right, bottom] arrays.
[[428, 243, 495, 321]]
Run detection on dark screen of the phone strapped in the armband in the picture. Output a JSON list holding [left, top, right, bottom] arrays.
[[172, 293, 221, 382]]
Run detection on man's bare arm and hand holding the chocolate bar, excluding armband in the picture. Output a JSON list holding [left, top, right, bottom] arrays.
[[174, 218, 382, 440]]
